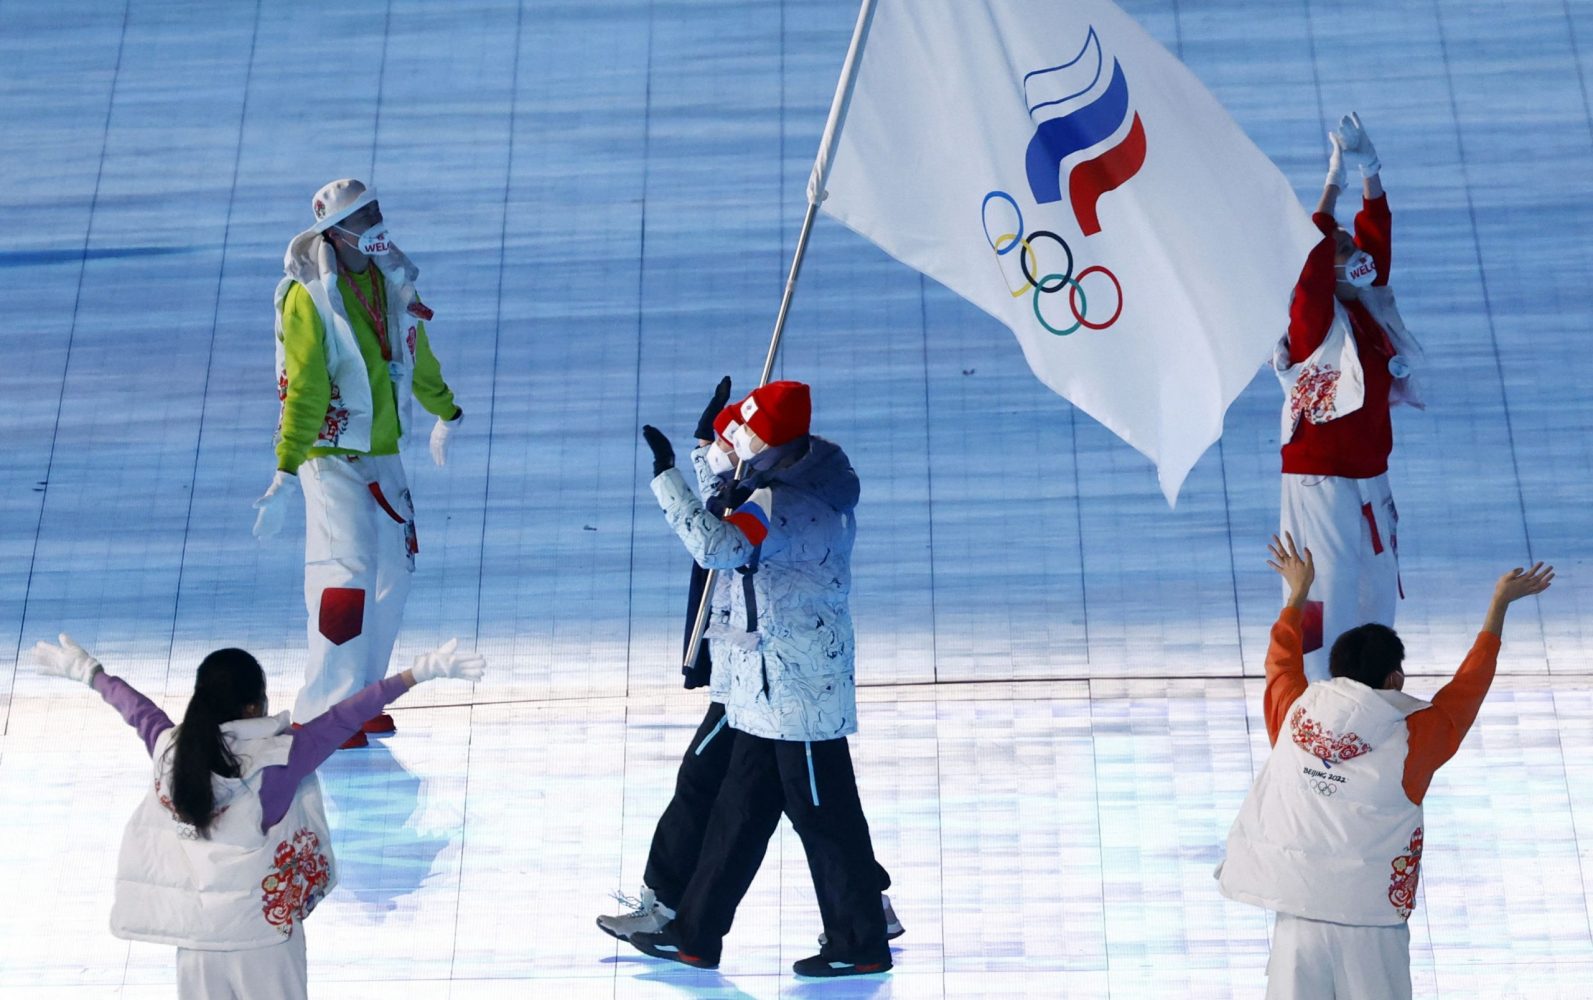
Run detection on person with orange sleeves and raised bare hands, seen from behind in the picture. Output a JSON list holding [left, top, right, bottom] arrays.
[[1217, 535, 1555, 1000]]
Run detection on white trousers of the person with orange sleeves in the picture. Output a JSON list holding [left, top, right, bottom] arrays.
[[1266, 912, 1410, 1000]]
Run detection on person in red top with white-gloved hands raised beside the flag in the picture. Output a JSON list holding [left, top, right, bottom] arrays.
[[1273, 113, 1423, 680]]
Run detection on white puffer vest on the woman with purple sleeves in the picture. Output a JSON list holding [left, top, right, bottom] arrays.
[[110, 712, 338, 951]]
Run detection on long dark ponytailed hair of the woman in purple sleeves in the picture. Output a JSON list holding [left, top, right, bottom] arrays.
[[172, 650, 266, 838]]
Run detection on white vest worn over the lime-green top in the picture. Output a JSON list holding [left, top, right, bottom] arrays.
[[276, 229, 421, 452]]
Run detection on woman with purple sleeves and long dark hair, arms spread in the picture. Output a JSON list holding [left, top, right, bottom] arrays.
[[33, 634, 486, 1000]]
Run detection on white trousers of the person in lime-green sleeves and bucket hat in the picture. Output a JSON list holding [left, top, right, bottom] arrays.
[[293, 455, 417, 723]]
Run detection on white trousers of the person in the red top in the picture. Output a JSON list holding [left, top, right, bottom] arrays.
[[1279, 473, 1400, 680]]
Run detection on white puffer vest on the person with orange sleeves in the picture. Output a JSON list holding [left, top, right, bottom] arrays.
[[1217, 677, 1429, 925]]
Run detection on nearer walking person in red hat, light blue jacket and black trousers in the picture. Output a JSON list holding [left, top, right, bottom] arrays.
[[629, 382, 890, 976]]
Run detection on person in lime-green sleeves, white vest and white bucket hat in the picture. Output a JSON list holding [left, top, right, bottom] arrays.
[[246, 180, 464, 747]]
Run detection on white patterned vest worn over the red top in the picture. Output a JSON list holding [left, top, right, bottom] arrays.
[[1273, 285, 1426, 444]]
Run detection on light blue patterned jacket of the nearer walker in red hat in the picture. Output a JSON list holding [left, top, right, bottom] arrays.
[[652, 436, 859, 742]]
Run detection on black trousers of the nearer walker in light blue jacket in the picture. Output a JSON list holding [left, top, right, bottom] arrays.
[[669, 728, 890, 962]]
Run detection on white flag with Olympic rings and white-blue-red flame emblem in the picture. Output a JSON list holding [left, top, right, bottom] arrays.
[[822, 0, 1321, 505]]
